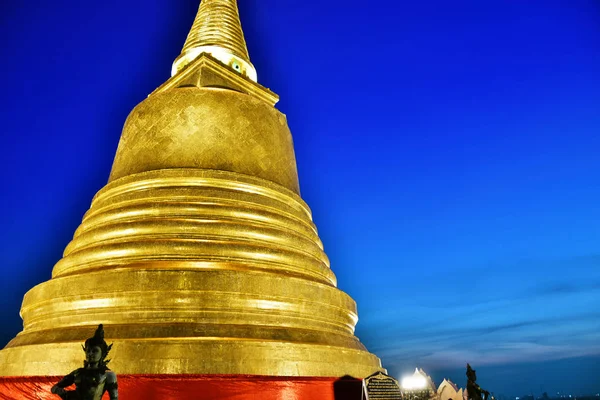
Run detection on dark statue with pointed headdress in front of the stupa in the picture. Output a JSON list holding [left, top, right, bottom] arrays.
[[52, 324, 119, 400]]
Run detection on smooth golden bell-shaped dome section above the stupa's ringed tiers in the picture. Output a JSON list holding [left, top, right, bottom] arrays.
[[110, 87, 299, 194]]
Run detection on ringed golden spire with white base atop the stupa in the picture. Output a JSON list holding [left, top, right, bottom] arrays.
[[171, 0, 257, 82]]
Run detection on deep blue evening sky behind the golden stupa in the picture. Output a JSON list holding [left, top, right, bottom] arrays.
[[0, 0, 600, 396]]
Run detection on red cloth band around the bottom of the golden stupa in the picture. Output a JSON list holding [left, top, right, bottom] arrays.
[[0, 375, 362, 400]]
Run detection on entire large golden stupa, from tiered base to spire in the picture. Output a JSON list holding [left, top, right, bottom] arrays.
[[0, 0, 381, 377]]
